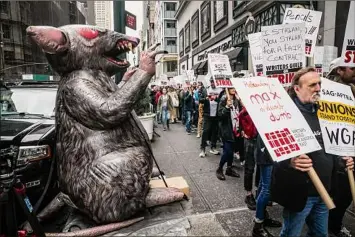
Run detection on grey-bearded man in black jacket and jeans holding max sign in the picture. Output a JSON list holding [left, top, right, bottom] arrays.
[[271, 68, 354, 237]]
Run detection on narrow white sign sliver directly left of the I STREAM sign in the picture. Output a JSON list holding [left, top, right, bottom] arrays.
[[248, 32, 263, 76]]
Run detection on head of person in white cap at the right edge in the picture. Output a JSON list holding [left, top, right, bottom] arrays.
[[327, 57, 355, 96]]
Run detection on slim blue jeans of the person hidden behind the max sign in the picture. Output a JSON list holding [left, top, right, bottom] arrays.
[[255, 165, 273, 220]]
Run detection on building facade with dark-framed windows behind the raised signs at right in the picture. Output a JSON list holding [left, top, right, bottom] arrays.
[[175, 1, 350, 75]]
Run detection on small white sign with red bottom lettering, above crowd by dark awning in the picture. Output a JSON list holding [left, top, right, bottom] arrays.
[[208, 53, 233, 88]]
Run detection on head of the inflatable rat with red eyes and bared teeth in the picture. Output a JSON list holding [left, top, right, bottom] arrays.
[[26, 25, 139, 75]]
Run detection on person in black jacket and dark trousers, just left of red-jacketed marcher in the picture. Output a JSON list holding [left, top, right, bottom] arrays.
[[216, 88, 240, 180]]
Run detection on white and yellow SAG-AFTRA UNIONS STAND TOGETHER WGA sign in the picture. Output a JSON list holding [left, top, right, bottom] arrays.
[[318, 78, 355, 157]]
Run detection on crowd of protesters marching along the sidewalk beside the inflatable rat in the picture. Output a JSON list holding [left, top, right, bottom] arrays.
[[152, 58, 355, 237]]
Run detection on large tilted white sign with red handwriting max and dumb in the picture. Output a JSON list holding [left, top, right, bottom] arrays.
[[232, 77, 322, 162]]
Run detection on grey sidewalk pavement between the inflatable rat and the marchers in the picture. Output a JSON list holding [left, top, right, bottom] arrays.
[[109, 123, 355, 236]]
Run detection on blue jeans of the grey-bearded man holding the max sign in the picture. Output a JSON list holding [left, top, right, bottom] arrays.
[[280, 197, 329, 237]]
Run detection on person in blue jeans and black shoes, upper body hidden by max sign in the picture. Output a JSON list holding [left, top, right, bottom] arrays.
[[252, 135, 281, 237]]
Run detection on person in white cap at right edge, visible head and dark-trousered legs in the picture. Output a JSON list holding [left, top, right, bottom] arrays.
[[327, 57, 355, 236]]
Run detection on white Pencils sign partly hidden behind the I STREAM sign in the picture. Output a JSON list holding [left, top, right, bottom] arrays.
[[282, 8, 322, 57]]
